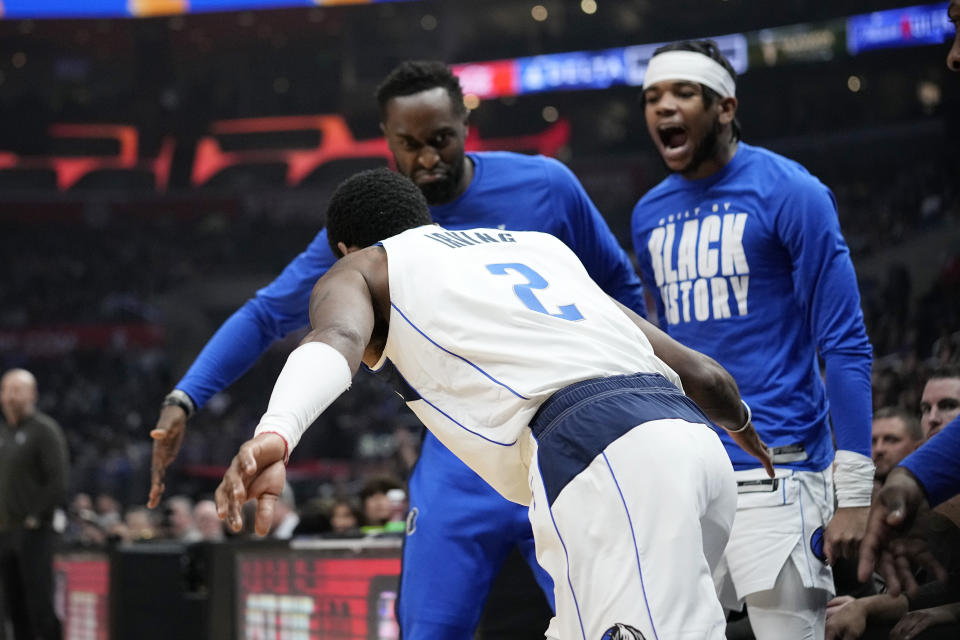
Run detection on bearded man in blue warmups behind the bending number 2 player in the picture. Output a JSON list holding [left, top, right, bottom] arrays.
[[149, 62, 645, 640]]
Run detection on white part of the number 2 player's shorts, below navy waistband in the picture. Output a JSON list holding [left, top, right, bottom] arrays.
[[530, 418, 736, 640]]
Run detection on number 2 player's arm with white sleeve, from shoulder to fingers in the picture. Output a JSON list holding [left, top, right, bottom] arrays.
[[215, 247, 389, 535]]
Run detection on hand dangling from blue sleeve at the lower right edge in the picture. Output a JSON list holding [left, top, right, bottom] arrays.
[[857, 467, 946, 596]]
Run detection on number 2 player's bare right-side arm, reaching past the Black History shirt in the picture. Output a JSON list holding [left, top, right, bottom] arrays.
[[617, 302, 774, 478]]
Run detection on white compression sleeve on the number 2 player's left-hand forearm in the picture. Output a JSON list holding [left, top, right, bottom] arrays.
[[254, 342, 353, 456]]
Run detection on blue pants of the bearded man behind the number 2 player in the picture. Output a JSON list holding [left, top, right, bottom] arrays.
[[397, 432, 553, 640]]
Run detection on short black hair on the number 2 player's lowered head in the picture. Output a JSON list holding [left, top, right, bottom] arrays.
[[327, 168, 433, 258]]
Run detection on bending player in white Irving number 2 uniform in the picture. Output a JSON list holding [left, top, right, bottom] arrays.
[[216, 170, 772, 640]]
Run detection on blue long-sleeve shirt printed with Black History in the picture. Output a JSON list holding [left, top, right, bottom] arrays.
[[632, 142, 872, 471]]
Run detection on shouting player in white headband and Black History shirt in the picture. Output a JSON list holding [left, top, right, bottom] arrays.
[[632, 41, 873, 640]]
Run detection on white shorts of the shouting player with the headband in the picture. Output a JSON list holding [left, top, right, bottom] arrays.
[[714, 467, 834, 610]]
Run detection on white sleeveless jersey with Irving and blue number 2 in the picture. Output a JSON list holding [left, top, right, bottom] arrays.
[[374, 225, 680, 504]]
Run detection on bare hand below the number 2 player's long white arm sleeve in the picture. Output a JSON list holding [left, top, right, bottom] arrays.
[[214, 433, 287, 536]]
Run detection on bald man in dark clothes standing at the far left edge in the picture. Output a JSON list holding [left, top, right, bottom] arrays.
[[0, 369, 69, 640]]
